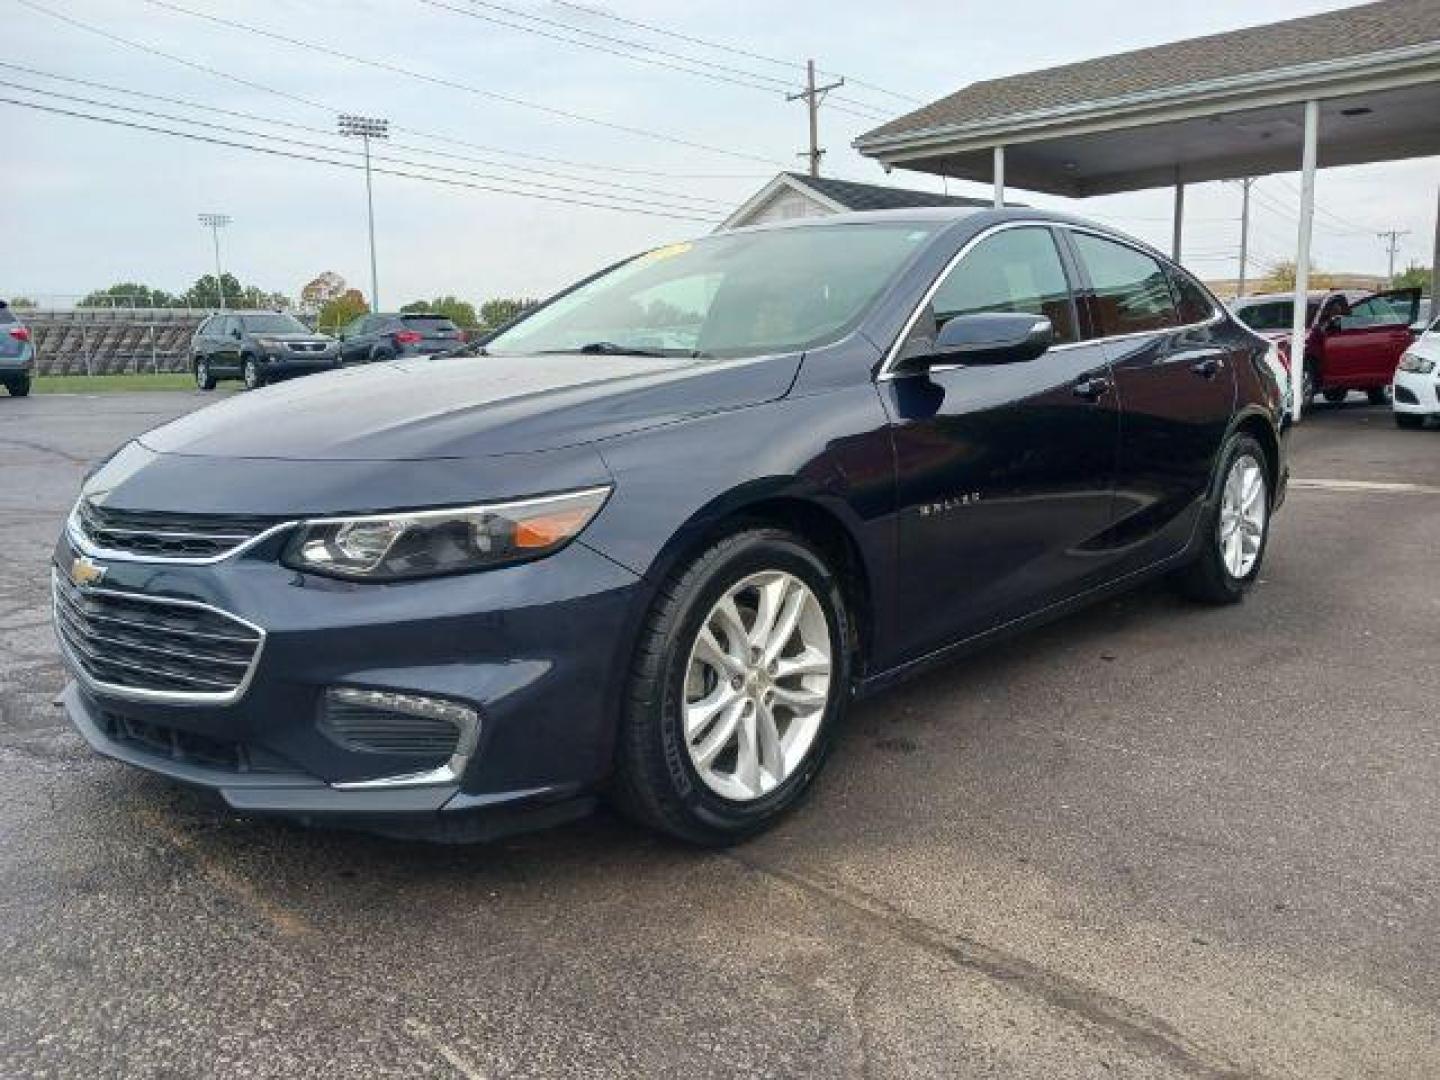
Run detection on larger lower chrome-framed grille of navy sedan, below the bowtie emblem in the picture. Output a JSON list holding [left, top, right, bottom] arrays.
[[50, 569, 265, 704]]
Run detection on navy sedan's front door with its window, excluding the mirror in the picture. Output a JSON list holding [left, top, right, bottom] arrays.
[[880, 226, 1119, 655]]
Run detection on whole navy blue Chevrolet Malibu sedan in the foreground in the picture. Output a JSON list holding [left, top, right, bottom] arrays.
[[53, 207, 1287, 844]]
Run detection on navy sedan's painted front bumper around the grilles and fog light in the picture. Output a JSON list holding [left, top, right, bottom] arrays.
[[56, 534, 645, 840]]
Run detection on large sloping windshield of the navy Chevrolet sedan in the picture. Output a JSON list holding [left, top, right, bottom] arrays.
[[485, 222, 937, 356]]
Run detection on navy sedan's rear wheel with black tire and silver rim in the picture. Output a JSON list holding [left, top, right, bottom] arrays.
[[1175, 435, 1270, 603]]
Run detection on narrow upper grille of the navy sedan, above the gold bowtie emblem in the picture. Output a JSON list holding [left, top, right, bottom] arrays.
[[71, 498, 281, 562]]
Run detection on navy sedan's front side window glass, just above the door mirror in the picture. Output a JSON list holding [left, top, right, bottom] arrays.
[[932, 228, 1077, 341]]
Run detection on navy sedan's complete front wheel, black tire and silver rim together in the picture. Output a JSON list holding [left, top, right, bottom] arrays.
[[613, 528, 851, 845]]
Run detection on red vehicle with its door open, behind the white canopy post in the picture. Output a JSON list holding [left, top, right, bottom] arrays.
[[1233, 289, 1420, 405]]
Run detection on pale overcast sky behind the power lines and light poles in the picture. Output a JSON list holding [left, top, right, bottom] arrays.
[[0, 0, 1440, 308]]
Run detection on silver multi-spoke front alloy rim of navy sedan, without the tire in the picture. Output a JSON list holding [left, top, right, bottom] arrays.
[[685, 570, 831, 802]]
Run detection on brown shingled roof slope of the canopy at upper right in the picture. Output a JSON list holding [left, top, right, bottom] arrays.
[[855, 0, 1440, 150]]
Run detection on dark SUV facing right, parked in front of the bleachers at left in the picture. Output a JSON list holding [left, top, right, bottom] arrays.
[[190, 311, 340, 390]]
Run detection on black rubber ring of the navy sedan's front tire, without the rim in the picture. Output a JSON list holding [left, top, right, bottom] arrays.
[[652, 533, 850, 838]]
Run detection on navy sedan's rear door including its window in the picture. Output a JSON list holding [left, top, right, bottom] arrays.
[[1068, 229, 1236, 573]]
